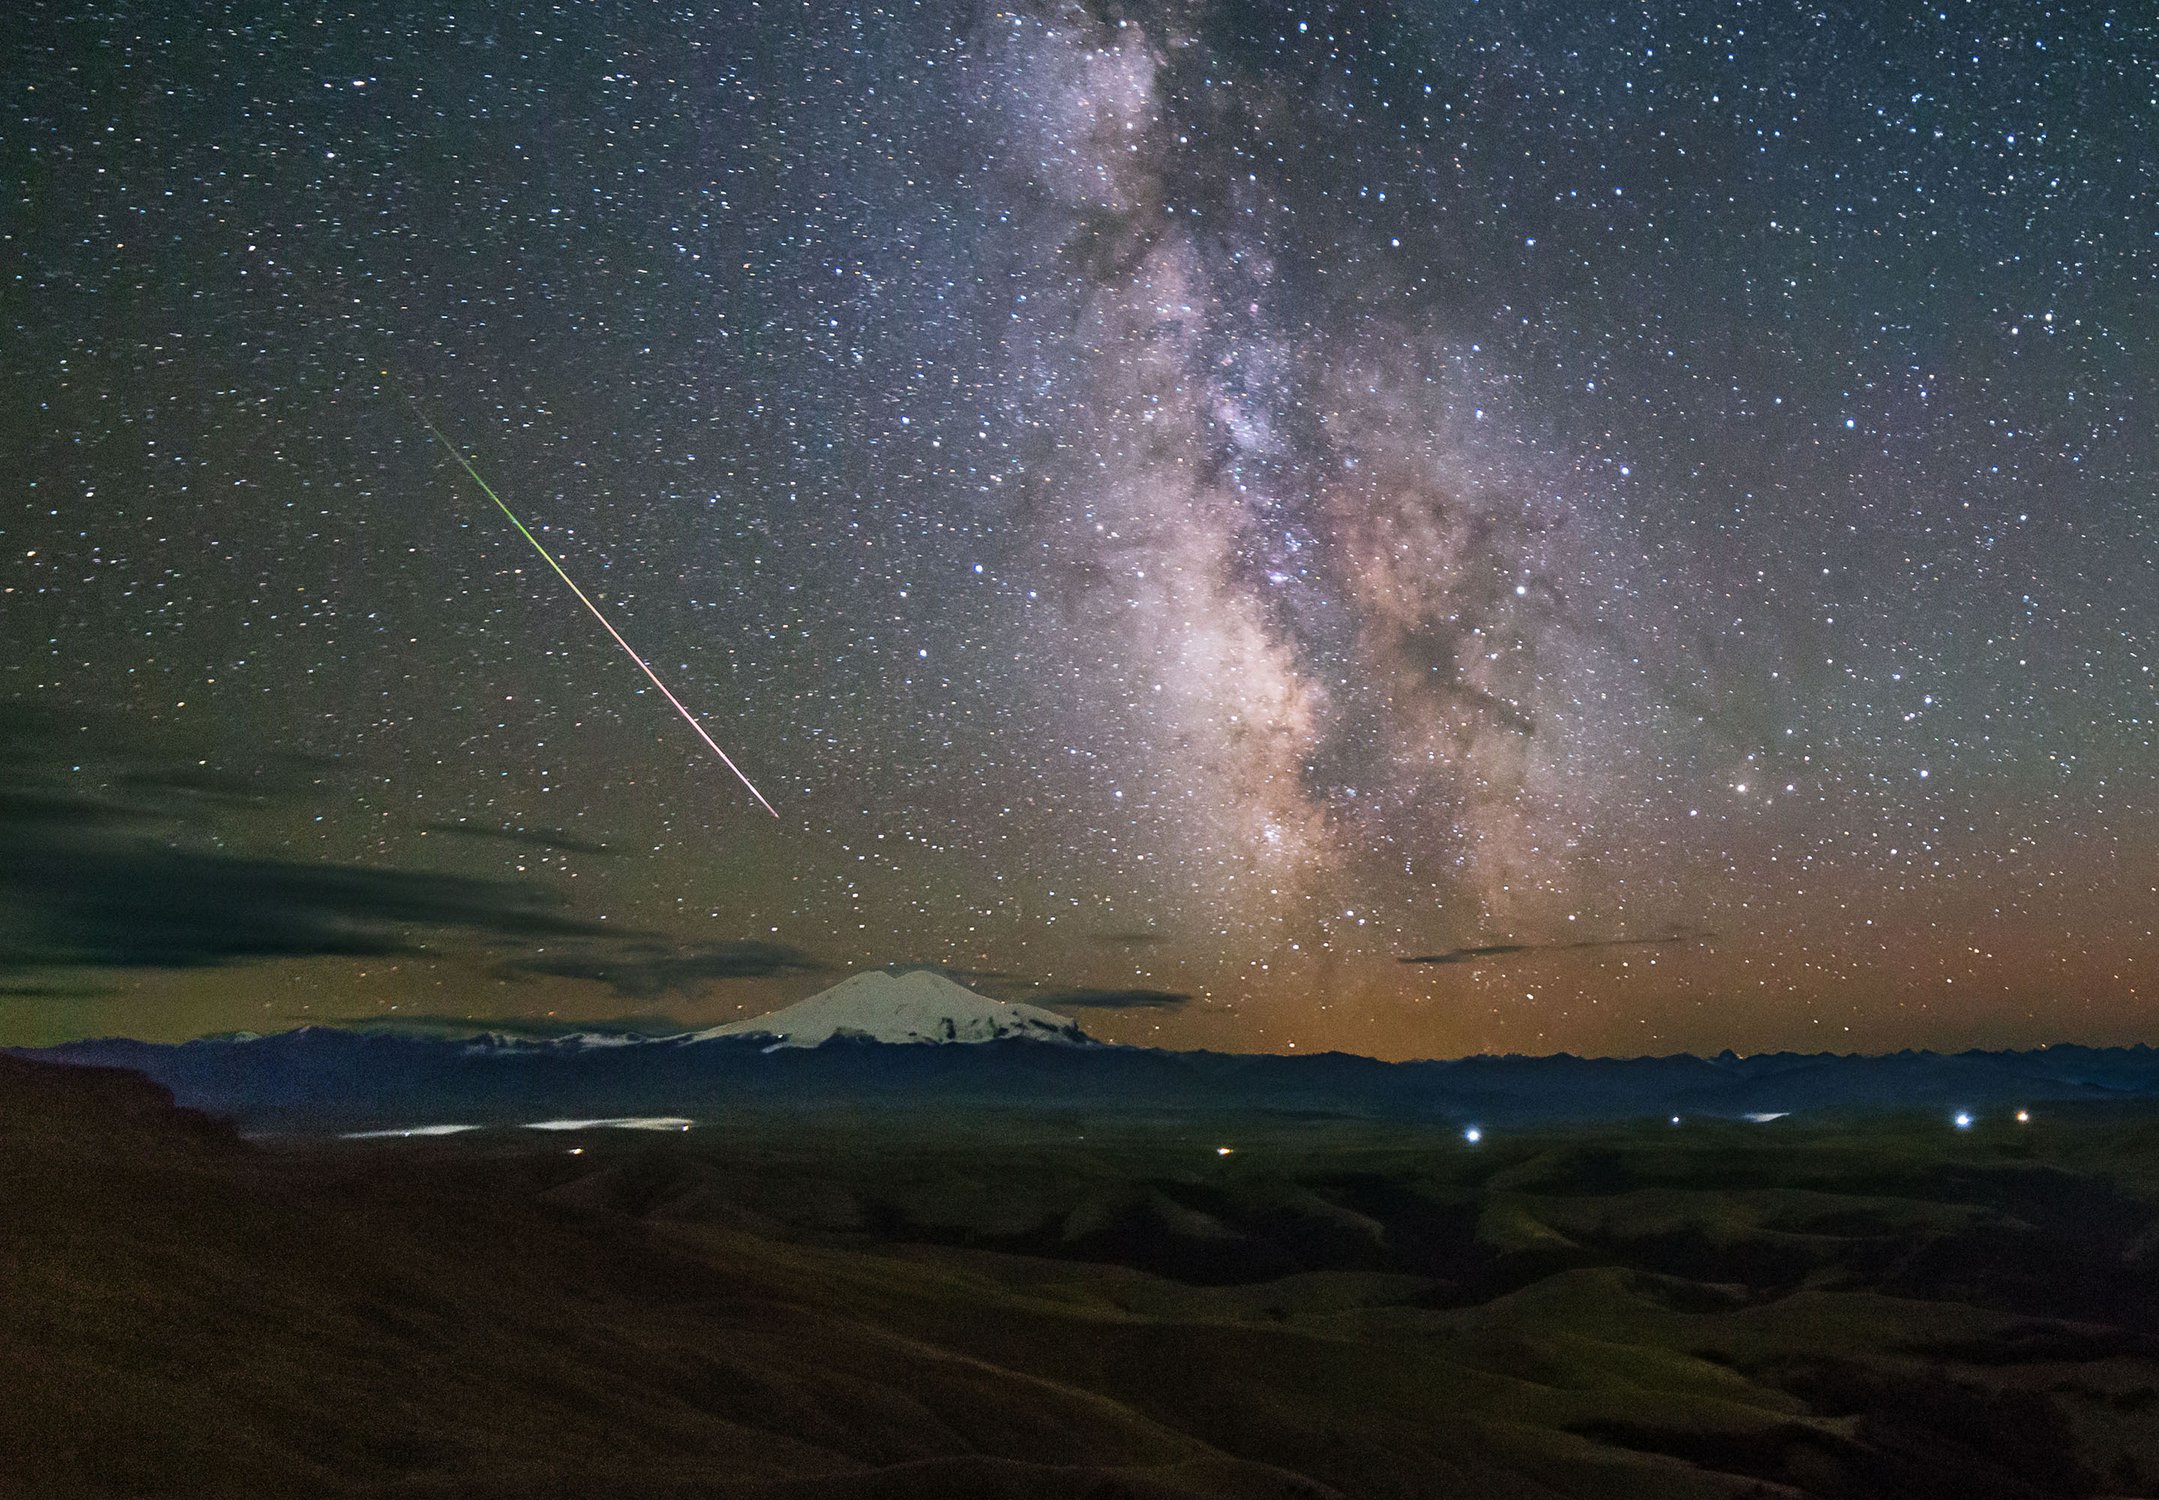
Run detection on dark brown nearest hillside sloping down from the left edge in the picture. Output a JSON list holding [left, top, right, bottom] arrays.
[[0, 1058, 1323, 1498]]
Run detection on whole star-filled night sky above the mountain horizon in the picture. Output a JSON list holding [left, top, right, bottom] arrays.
[[0, 0, 2159, 1058]]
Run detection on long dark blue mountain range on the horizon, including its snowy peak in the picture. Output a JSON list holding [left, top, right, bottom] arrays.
[[17, 971, 2159, 1131]]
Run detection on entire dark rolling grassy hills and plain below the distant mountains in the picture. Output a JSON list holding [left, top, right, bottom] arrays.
[[0, 1060, 2159, 1500]]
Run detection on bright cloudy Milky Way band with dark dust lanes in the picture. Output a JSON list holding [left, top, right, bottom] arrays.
[[963, 6, 1608, 932]]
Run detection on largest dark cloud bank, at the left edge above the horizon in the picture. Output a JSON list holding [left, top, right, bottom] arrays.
[[0, 714, 605, 973]]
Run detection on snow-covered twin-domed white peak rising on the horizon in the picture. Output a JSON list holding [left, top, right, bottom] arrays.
[[687, 969, 1088, 1047]]
